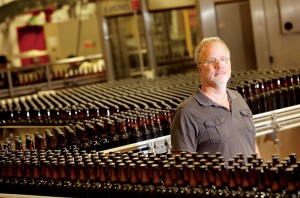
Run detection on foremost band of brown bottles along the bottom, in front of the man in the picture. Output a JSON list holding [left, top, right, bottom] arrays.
[[0, 150, 300, 197]]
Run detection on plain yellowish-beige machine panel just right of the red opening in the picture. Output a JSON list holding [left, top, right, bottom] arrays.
[[44, 18, 103, 61]]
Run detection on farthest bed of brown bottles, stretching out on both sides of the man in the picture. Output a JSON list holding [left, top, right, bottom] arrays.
[[0, 69, 300, 124]]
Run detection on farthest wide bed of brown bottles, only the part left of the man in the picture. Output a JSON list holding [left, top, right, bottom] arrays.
[[0, 67, 188, 124]]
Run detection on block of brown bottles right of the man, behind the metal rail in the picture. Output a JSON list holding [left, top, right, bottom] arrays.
[[231, 70, 300, 114]]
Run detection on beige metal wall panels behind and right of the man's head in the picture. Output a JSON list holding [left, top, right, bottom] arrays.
[[199, 0, 300, 69]]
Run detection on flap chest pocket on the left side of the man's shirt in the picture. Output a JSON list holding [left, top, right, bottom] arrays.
[[204, 116, 231, 144]]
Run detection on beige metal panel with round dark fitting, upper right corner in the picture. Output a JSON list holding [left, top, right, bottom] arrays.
[[250, 0, 300, 69]]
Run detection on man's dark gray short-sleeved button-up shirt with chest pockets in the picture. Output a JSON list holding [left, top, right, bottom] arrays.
[[171, 89, 255, 162]]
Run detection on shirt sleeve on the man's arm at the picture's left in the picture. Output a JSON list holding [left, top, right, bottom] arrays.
[[171, 107, 198, 152]]
